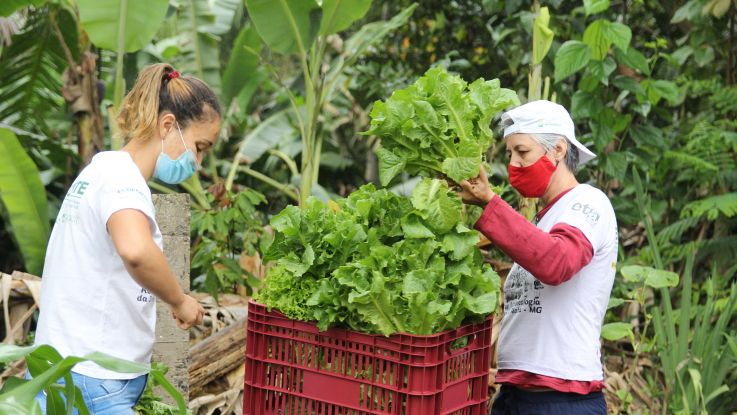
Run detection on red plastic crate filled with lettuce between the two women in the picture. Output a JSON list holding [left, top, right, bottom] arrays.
[[243, 301, 492, 415]]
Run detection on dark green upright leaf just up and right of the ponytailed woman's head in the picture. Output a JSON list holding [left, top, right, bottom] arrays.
[[222, 24, 262, 105]]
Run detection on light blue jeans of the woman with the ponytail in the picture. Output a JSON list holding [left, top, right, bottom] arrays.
[[26, 372, 148, 415]]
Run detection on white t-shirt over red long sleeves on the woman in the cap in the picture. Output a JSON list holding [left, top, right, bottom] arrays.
[[497, 184, 618, 381]]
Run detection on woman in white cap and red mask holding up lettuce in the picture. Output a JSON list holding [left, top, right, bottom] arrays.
[[460, 101, 618, 415]]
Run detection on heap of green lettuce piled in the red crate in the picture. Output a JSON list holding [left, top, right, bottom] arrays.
[[256, 179, 500, 335]]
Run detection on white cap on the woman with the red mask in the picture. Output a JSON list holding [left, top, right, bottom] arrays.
[[504, 100, 596, 165]]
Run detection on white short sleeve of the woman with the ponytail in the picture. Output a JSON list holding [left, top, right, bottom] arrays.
[[99, 178, 155, 230]]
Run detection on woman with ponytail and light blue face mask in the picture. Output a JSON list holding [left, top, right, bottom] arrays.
[[36, 64, 221, 415]]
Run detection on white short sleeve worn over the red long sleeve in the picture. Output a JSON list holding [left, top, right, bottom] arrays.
[[556, 188, 614, 253]]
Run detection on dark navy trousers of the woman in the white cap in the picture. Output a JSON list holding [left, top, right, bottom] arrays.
[[491, 385, 607, 415]]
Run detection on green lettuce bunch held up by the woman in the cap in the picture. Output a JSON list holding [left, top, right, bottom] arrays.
[[364, 67, 519, 186]]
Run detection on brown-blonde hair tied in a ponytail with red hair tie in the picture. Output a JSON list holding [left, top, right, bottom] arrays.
[[118, 63, 221, 141]]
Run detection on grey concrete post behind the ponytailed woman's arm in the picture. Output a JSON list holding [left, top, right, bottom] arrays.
[[152, 194, 190, 404]]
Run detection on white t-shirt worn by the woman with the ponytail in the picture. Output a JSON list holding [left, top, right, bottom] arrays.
[[36, 151, 162, 379]]
